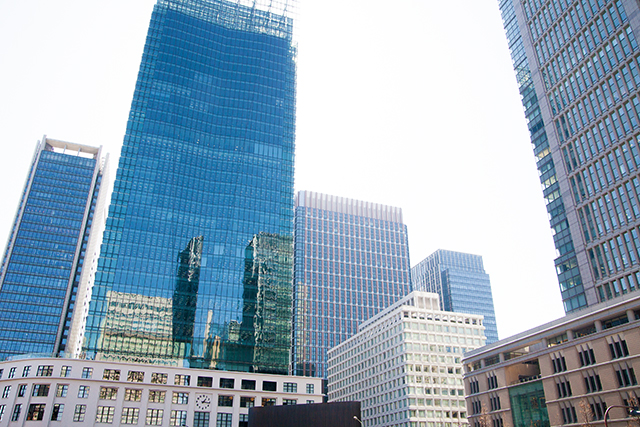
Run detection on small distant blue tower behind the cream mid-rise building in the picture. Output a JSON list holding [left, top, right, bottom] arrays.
[[411, 249, 498, 343]]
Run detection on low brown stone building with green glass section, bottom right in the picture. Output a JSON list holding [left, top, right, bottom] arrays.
[[463, 294, 640, 427]]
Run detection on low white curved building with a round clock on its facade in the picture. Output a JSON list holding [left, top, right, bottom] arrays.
[[0, 358, 322, 427]]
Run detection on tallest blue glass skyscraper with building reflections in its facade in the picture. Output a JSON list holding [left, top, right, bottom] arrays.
[[85, 0, 296, 373]]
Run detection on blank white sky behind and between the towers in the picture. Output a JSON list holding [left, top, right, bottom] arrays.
[[0, 0, 564, 338]]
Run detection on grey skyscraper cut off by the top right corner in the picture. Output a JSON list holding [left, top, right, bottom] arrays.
[[499, 0, 640, 312]]
